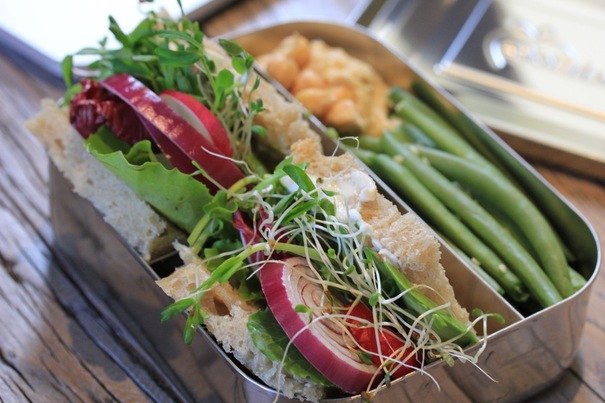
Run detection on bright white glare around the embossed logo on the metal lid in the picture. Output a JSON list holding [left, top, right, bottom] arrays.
[[450, 0, 605, 121]]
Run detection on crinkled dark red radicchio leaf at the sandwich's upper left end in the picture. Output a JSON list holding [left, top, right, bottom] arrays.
[[69, 79, 151, 144]]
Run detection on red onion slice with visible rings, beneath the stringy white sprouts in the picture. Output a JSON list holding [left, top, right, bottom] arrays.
[[260, 257, 379, 394]]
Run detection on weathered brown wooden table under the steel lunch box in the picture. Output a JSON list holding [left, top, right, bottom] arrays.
[[0, 0, 605, 402]]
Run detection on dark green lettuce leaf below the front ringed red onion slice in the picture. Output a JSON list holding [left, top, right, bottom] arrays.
[[248, 309, 333, 386]]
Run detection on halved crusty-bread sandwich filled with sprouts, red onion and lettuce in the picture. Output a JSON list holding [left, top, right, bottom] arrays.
[[27, 4, 480, 401]]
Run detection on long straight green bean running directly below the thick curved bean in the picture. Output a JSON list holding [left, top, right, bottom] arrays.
[[383, 133, 561, 307]]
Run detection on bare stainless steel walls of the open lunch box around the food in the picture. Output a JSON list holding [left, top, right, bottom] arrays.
[[51, 21, 601, 402]]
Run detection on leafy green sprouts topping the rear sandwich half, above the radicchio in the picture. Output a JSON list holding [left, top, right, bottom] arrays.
[[62, 7, 265, 170]]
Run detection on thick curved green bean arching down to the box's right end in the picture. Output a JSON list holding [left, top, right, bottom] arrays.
[[421, 148, 572, 297]]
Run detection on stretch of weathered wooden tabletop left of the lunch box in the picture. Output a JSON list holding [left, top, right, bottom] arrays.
[[0, 24, 173, 402]]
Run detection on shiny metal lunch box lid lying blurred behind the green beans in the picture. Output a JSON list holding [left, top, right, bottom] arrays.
[[369, 0, 605, 178]]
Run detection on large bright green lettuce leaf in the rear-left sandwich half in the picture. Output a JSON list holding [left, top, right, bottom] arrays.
[[84, 128, 212, 233]]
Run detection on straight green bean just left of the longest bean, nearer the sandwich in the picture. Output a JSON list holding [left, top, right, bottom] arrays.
[[368, 154, 529, 302]]
